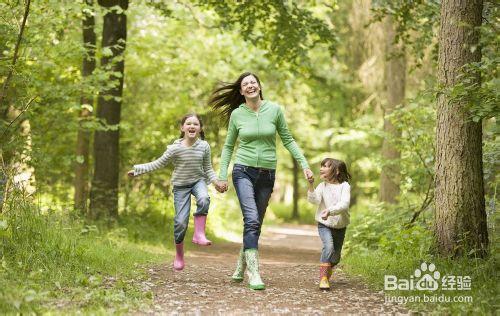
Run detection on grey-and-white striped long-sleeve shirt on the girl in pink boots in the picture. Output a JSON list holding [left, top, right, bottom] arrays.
[[134, 139, 217, 186]]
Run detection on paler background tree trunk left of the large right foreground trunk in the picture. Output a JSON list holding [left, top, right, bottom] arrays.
[[380, 17, 406, 204]]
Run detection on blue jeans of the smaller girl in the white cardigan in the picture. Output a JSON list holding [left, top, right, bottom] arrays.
[[318, 223, 346, 267]]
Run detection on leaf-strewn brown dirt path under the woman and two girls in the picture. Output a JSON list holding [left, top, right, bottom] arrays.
[[135, 226, 408, 315]]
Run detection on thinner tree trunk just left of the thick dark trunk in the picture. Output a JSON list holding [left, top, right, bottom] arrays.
[[74, 0, 96, 214]]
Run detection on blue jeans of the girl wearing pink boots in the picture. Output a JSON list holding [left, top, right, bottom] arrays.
[[173, 180, 210, 244]]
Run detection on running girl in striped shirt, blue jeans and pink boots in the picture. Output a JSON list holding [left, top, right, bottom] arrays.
[[127, 114, 221, 271]]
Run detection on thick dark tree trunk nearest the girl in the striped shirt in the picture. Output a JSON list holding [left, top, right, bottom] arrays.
[[89, 0, 128, 219]]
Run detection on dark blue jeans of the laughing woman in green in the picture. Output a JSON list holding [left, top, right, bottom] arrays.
[[233, 164, 276, 249]]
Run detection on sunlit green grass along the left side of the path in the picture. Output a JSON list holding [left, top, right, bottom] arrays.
[[0, 198, 167, 314]]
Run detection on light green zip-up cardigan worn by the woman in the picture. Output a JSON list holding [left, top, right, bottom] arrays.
[[219, 100, 309, 180]]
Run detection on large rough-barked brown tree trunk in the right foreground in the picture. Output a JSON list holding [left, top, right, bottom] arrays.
[[434, 0, 488, 256]]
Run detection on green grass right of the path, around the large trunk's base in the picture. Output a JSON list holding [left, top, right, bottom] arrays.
[[341, 200, 499, 315]]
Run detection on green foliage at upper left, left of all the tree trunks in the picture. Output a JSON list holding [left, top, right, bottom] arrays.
[[0, 1, 87, 192]]
